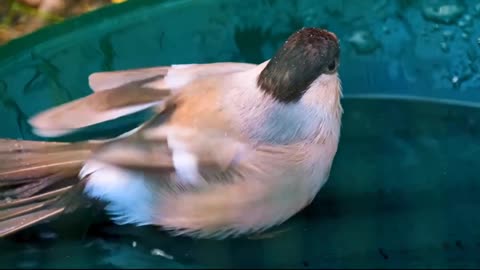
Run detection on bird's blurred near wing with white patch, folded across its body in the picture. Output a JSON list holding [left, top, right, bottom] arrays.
[[87, 125, 292, 188]]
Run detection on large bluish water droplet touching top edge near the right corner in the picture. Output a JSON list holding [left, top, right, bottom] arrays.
[[422, 0, 465, 24]]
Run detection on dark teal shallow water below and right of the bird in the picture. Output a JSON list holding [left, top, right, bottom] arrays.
[[0, 98, 480, 268]]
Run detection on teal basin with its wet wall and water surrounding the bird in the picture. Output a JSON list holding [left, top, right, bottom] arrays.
[[0, 0, 480, 268]]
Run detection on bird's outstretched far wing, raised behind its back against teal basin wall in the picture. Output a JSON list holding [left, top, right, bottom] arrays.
[[29, 63, 255, 137]]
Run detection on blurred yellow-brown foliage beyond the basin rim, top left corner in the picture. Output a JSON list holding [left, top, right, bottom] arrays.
[[0, 0, 125, 45]]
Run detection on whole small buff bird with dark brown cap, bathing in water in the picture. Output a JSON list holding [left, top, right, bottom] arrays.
[[0, 27, 343, 239]]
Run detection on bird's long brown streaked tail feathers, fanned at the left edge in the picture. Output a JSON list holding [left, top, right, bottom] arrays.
[[0, 139, 96, 237]]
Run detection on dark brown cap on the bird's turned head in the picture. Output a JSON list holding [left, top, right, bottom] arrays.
[[257, 28, 340, 103]]
